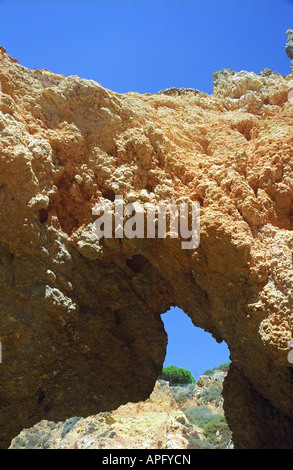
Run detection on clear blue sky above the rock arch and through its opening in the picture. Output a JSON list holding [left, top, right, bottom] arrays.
[[0, 0, 293, 377]]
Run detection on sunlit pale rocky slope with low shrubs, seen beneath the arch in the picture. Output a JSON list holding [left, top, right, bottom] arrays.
[[10, 369, 233, 449]]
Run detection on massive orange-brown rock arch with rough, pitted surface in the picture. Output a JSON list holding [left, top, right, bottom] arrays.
[[0, 48, 293, 448]]
